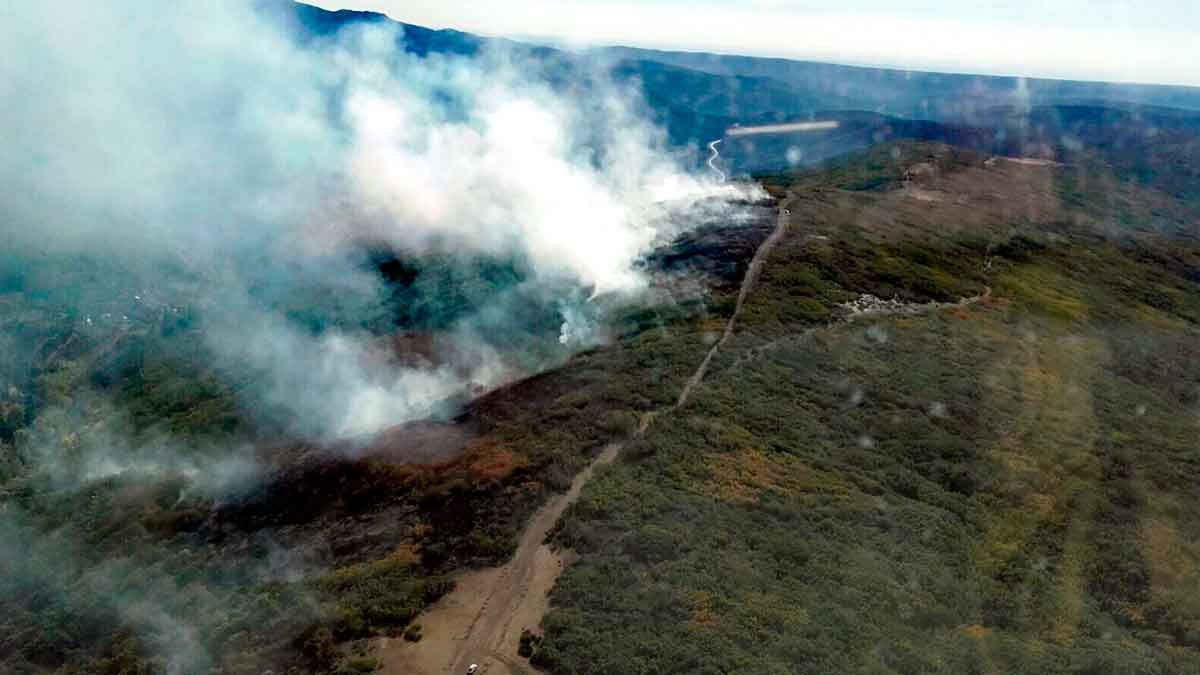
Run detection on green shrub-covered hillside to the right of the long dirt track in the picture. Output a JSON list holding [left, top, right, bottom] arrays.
[[535, 144, 1200, 674]]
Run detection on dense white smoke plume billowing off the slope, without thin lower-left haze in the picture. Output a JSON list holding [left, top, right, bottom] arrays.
[[0, 0, 744, 436]]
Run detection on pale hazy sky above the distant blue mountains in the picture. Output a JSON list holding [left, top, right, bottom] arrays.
[[313, 0, 1200, 85]]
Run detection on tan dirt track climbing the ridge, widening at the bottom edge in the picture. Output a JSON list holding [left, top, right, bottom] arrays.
[[376, 203, 790, 675]]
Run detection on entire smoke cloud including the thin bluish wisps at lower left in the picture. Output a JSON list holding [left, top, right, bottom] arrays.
[[0, 0, 758, 671]]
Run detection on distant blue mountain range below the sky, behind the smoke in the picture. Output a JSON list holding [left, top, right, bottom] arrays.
[[272, 0, 1200, 174]]
